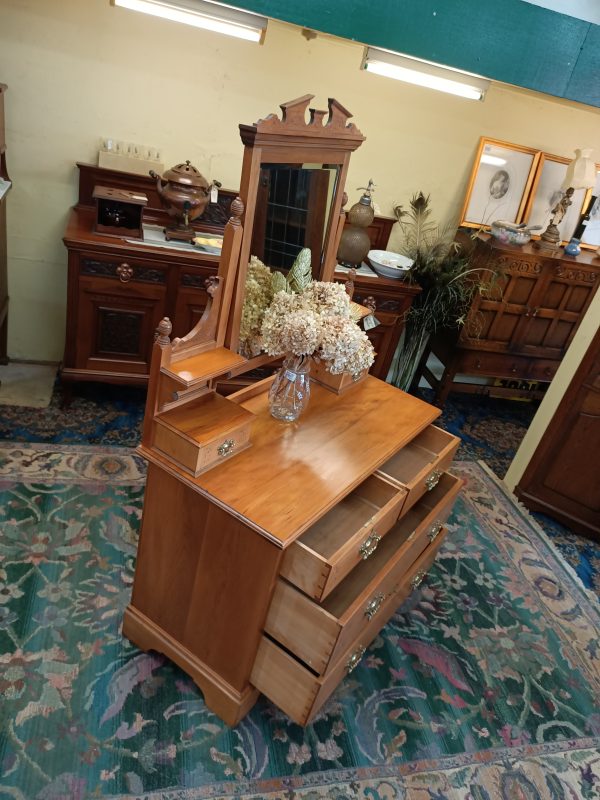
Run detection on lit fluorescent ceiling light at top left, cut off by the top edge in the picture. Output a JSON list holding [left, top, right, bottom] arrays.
[[111, 0, 267, 42]]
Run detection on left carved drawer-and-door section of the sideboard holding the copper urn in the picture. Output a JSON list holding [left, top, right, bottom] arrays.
[[75, 256, 166, 377]]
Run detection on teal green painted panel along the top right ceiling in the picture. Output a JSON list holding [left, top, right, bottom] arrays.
[[235, 0, 600, 107]]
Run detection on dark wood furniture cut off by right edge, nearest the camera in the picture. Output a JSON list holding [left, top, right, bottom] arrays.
[[515, 330, 600, 538]]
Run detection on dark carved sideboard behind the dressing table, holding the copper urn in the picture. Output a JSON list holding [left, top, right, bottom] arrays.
[[61, 164, 420, 385]]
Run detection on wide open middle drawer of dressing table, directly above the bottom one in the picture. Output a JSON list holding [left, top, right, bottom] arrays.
[[265, 473, 461, 675]]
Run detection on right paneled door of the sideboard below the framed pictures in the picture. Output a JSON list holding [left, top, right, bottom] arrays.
[[518, 259, 600, 359]]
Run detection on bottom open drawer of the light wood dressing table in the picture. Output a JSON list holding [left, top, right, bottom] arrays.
[[250, 530, 445, 725]]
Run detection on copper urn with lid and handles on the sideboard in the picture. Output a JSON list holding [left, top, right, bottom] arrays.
[[150, 161, 221, 242]]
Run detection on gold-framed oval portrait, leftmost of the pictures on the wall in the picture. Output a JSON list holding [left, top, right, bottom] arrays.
[[460, 137, 540, 229]]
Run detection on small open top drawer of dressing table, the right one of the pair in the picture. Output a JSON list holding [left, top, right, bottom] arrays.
[[375, 425, 460, 513]]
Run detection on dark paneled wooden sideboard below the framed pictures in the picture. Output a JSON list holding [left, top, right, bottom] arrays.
[[422, 235, 600, 404]]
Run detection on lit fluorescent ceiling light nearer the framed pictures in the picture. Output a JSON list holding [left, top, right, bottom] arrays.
[[362, 47, 490, 100]]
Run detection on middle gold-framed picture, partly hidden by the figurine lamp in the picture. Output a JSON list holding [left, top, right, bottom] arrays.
[[524, 153, 588, 244]]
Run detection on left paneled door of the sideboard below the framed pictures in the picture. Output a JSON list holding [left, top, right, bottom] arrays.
[[459, 254, 542, 353]]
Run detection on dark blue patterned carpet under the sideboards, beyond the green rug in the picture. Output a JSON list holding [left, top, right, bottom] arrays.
[[0, 381, 600, 594]]
